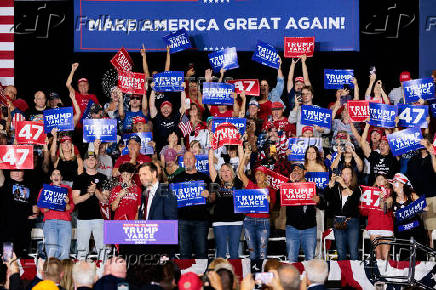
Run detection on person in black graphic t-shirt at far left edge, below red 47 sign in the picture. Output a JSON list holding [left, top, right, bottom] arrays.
[[0, 169, 38, 257]]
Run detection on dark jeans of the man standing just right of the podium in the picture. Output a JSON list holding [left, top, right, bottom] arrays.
[[179, 220, 209, 259]]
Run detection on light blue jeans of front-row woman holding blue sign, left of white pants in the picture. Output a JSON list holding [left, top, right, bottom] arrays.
[[43, 219, 72, 260]]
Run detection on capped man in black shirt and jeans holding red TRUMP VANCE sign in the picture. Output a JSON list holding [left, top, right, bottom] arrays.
[[286, 163, 319, 263]]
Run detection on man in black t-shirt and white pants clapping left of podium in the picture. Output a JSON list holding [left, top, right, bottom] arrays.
[[73, 152, 107, 259]]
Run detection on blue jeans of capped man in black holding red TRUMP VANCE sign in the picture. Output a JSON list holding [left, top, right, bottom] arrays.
[[286, 226, 316, 263]]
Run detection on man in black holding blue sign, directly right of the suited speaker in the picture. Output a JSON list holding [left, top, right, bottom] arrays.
[[173, 151, 211, 259]]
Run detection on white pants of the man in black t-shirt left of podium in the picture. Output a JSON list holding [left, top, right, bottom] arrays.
[[76, 219, 104, 259]]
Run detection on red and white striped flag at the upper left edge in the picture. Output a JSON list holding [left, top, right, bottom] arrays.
[[0, 0, 14, 86]]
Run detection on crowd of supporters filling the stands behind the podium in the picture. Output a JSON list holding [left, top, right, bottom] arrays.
[[0, 48, 436, 272]]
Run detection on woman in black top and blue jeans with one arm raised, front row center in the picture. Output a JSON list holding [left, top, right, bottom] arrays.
[[209, 149, 244, 259]]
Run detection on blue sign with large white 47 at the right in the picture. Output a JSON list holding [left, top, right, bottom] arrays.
[[398, 104, 428, 128]]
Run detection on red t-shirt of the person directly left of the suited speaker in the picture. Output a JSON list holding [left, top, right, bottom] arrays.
[[109, 184, 141, 220]]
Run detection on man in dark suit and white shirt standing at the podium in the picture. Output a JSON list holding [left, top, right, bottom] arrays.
[[138, 163, 177, 220]]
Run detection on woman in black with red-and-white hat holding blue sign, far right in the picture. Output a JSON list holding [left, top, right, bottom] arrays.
[[390, 173, 428, 260]]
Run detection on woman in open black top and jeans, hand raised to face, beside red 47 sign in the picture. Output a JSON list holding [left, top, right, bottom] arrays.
[[325, 167, 361, 260]]
